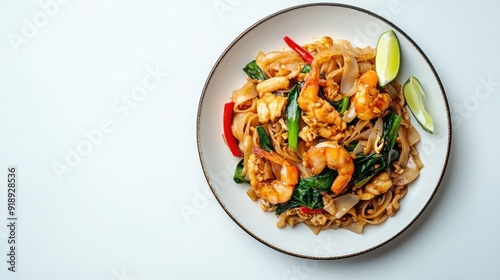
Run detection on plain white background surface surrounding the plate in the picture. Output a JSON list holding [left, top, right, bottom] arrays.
[[0, 0, 500, 280]]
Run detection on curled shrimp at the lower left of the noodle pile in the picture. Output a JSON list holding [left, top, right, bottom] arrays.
[[248, 147, 299, 204]]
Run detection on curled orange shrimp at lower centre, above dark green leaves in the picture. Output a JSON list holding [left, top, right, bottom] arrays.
[[303, 141, 354, 194]]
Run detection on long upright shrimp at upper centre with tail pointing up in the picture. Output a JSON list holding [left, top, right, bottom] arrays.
[[297, 53, 346, 139]]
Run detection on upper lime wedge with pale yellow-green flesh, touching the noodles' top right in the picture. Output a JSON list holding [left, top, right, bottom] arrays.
[[375, 30, 400, 87]]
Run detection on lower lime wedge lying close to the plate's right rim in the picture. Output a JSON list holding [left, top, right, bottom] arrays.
[[403, 76, 434, 133]]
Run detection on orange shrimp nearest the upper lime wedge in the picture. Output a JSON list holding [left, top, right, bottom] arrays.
[[351, 70, 392, 121]]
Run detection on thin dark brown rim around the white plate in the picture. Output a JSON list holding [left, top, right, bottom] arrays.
[[196, 2, 452, 260]]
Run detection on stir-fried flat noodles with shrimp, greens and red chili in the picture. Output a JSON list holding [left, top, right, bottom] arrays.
[[224, 36, 423, 234]]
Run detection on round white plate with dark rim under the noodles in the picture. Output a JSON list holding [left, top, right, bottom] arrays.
[[197, 3, 451, 259]]
